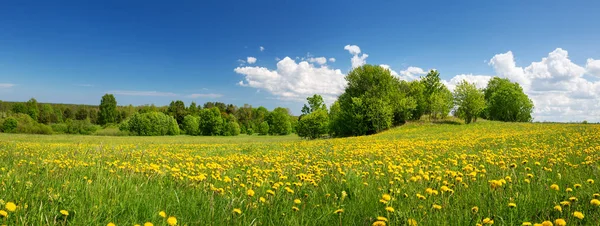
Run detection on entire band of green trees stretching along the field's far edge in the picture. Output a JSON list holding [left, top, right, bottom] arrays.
[[0, 65, 533, 139]]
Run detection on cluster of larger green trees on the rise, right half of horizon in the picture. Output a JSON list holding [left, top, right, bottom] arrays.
[[297, 65, 533, 139]]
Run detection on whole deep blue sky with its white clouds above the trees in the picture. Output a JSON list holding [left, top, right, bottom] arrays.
[[0, 1, 600, 121]]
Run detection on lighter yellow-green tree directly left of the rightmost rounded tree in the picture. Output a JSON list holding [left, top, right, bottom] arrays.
[[454, 80, 485, 124]]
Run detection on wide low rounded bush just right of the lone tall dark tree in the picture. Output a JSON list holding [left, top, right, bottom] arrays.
[[119, 112, 179, 136]]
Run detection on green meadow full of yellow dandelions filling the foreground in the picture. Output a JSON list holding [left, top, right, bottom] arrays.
[[0, 122, 600, 226]]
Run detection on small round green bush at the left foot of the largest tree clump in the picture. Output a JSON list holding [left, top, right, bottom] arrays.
[[297, 109, 329, 139]]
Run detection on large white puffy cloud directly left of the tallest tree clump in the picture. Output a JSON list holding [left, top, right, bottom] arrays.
[[234, 57, 346, 103]]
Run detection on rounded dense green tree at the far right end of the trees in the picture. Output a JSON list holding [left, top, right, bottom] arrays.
[[484, 77, 533, 122]]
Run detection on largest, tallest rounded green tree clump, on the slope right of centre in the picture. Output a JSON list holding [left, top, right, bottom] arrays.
[[330, 65, 416, 136]]
